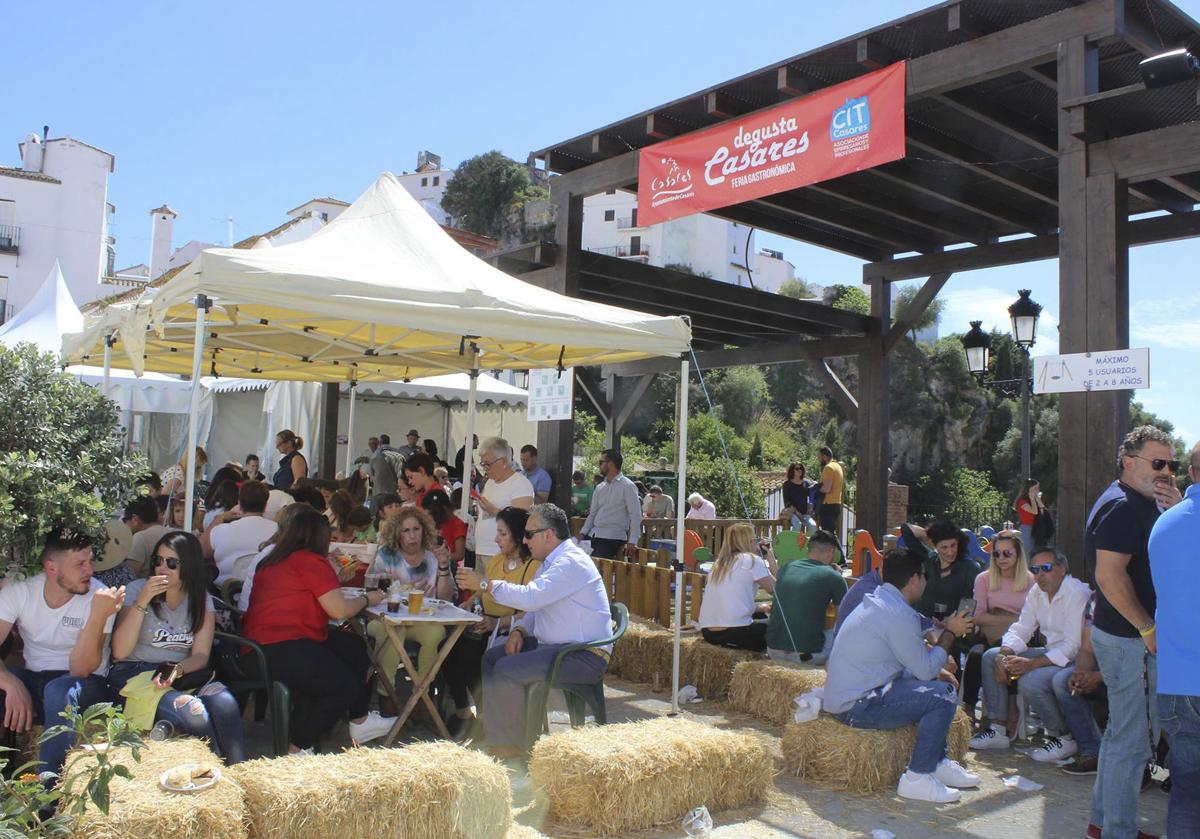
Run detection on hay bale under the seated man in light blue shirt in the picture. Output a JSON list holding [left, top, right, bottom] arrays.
[[781, 708, 971, 792]]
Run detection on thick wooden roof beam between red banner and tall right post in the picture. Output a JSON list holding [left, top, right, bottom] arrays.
[[907, 0, 1121, 96]]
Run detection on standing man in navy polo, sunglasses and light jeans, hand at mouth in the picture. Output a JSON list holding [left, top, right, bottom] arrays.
[[1084, 425, 1184, 839]]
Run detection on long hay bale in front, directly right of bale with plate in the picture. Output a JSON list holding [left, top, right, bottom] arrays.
[[230, 742, 512, 839]]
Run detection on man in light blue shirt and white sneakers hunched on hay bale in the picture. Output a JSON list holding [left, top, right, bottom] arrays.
[[822, 550, 979, 804]]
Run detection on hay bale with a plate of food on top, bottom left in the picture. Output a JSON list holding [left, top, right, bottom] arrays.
[[67, 738, 247, 839]]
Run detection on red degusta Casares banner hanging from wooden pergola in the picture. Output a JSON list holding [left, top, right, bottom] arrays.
[[637, 61, 905, 224]]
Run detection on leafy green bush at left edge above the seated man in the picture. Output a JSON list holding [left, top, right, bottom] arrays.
[[0, 343, 146, 575]]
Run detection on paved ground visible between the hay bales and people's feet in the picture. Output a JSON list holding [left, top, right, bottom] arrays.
[[238, 679, 1166, 839]]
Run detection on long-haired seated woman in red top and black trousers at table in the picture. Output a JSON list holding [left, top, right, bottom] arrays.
[[242, 508, 396, 754]]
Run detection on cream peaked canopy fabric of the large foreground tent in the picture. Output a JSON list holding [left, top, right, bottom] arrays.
[[65, 173, 691, 382]]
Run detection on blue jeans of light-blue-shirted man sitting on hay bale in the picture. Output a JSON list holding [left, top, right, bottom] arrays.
[[835, 677, 959, 774]]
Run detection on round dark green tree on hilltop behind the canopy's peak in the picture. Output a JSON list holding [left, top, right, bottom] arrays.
[[442, 151, 548, 239]]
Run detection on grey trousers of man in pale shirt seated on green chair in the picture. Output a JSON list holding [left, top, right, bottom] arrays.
[[484, 639, 608, 748]]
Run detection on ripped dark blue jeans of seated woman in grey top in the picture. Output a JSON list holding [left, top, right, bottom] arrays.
[[108, 661, 246, 765]]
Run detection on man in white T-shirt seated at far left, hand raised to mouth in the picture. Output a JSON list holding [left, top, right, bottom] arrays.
[[0, 530, 123, 772]]
